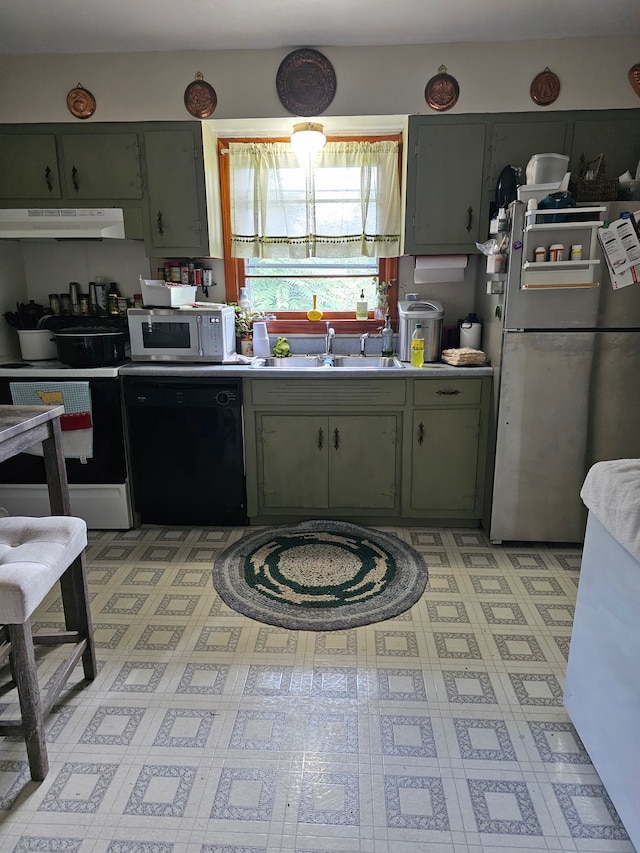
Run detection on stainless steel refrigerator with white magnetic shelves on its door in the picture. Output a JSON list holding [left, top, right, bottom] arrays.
[[487, 202, 640, 542]]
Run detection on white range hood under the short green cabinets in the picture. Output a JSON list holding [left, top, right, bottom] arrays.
[[0, 207, 124, 240]]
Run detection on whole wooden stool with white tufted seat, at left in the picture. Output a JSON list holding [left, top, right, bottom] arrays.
[[0, 516, 97, 781]]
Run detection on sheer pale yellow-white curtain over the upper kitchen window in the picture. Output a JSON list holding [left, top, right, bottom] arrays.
[[228, 141, 400, 258]]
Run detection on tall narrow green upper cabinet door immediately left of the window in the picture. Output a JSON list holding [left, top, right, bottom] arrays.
[[144, 130, 207, 255]]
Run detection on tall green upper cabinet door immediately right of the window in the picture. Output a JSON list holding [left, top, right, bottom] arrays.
[[404, 118, 486, 255]]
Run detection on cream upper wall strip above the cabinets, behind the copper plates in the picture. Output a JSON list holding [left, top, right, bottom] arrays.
[[0, 37, 640, 123]]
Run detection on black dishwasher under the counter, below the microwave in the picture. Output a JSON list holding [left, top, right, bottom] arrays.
[[123, 376, 247, 526]]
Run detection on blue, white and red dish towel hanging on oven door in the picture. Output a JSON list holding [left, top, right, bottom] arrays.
[[9, 382, 93, 462]]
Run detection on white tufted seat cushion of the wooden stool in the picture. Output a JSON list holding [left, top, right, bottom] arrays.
[[0, 515, 87, 625]]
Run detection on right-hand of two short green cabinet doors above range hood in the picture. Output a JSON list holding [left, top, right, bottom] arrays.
[[60, 133, 142, 201]]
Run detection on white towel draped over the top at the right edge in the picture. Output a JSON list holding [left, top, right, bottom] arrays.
[[580, 459, 640, 569]]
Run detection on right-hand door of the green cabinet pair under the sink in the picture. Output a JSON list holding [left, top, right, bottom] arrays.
[[329, 415, 398, 511]]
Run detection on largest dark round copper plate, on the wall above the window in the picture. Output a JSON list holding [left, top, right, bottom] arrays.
[[276, 47, 336, 116]]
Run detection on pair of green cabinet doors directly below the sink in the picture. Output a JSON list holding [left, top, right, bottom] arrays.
[[256, 413, 400, 515]]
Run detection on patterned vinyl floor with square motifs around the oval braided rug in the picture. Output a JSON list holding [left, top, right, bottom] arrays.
[[0, 527, 634, 853]]
